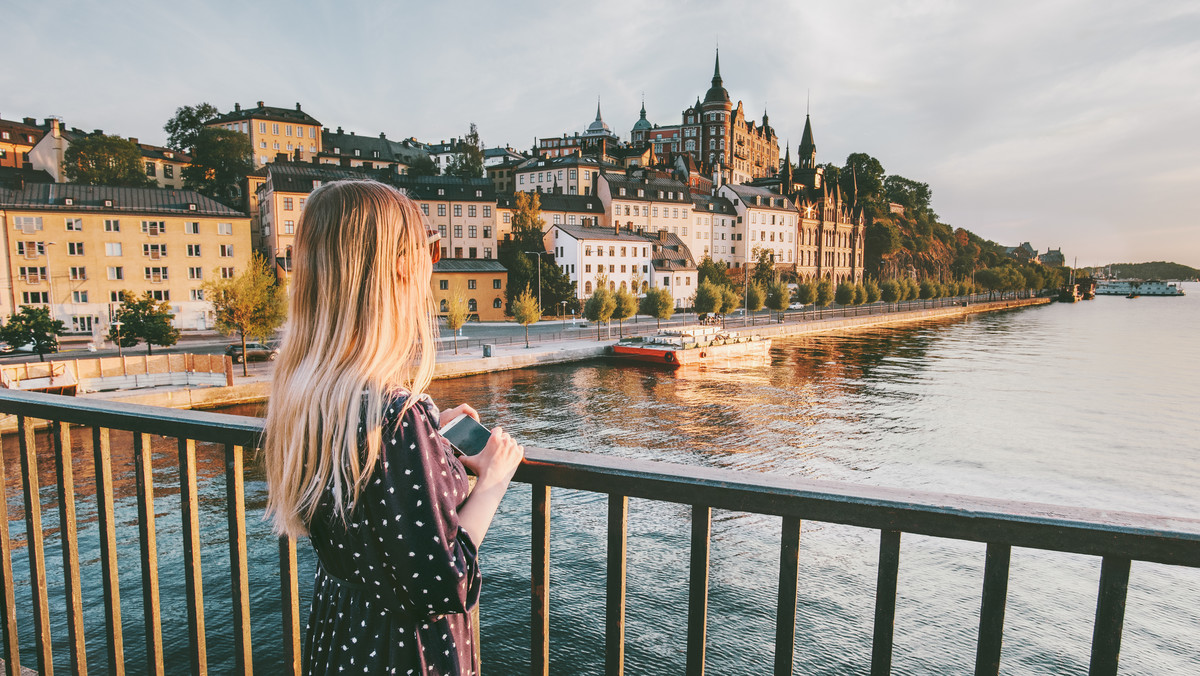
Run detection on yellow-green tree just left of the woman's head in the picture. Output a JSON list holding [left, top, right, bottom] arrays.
[[204, 253, 288, 376]]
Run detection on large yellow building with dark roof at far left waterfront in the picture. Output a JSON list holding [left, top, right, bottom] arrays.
[[0, 184, 251, 335]]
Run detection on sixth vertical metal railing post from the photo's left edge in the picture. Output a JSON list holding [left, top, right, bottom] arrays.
[[179, 437, 209, 675]]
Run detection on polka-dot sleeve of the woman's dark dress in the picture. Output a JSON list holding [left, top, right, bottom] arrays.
[[366, 402, 481, 616]]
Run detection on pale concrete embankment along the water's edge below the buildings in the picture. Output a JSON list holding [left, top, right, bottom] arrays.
[[75, 298, 1049, 408]]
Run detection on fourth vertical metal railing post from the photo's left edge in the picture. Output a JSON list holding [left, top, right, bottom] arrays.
[[91, 427, 125, 676]]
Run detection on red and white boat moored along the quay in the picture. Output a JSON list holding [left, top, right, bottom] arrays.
[[612, 327, 770, 369]]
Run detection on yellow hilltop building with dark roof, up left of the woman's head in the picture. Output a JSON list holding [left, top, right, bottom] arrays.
[[205, 101, 322, 169]]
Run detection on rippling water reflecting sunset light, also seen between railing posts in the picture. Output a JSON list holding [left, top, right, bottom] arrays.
[[5, 285, 1200, 675]]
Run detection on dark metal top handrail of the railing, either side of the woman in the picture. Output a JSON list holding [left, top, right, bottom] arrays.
[[0, 390, 1200, 568]]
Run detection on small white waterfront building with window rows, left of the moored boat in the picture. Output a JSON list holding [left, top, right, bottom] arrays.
[[542, 223, 652, 301]]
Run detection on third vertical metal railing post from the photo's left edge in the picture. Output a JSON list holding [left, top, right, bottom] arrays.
[[50, 421, 88, 674]]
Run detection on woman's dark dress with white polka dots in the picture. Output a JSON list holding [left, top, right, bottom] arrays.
[[304, 394, 481, 676]]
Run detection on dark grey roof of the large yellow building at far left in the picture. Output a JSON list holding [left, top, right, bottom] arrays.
[[0, 183, 246, 219]]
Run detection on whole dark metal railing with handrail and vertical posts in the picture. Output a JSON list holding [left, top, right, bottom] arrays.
[[0, 391, 1200, 676]]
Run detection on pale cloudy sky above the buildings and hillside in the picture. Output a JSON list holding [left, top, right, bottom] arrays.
[[9, 0, 1200, 267]]
